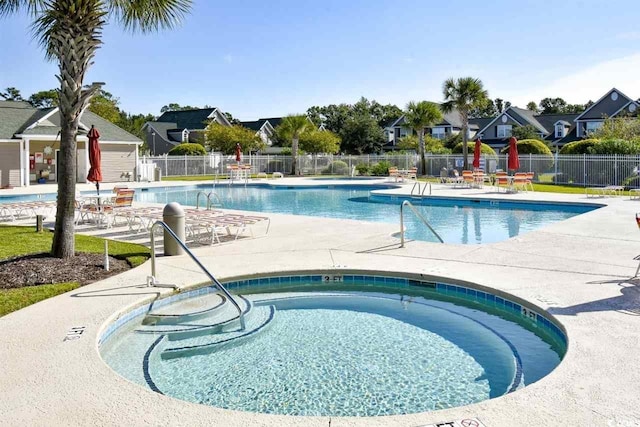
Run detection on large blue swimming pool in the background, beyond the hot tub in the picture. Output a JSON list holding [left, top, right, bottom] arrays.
[[136, 185, 595, 244]]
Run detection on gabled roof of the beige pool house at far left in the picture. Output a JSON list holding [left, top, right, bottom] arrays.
[[0, 101, 141, 143]]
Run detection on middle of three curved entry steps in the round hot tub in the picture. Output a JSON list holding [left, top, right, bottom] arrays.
[[136, 295, 252, 340]]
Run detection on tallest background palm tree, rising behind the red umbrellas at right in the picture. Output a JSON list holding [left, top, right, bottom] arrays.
[[441, 77, 488, 169]]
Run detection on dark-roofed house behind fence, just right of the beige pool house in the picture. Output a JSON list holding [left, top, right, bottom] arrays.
[[142, 108, 231, 156]]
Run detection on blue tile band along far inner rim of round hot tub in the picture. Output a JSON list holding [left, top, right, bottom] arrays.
[[97, 271, 568, 358]]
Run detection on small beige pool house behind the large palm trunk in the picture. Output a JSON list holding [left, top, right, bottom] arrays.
[[0, 101, 142, 188]]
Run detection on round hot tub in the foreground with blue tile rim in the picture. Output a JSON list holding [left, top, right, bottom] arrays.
[[100, 273, 566, 416]]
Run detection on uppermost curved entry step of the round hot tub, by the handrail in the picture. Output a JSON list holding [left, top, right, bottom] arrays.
[[142, 293, 227, 325]]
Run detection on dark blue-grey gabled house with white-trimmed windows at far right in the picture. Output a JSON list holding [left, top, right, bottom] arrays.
[[478, 88, 640, 148]]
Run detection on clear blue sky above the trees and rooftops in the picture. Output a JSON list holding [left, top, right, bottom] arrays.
[[0, 0, 640, 120]]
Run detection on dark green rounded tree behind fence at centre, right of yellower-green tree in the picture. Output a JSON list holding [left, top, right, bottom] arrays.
[[340, 114, 385, 154]]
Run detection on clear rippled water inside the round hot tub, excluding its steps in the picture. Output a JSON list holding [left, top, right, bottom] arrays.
[[100, 282, 561, 416]]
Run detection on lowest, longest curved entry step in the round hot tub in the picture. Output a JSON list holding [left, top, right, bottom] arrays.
[[160, 305, 276, 359]]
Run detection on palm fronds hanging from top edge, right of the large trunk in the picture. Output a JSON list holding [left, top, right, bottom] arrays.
[[109, 0, 193, 33]]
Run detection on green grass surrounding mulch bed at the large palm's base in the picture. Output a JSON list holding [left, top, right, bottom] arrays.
[[0, 225, 150, 316]]
